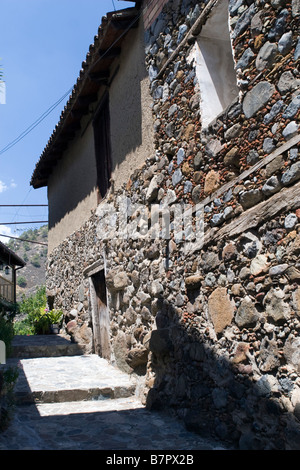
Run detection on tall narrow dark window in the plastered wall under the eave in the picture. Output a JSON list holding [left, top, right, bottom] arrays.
[[93, 95, 112, 203]]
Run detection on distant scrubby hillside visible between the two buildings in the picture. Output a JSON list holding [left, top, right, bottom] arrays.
[[7, 225, 48, 300]]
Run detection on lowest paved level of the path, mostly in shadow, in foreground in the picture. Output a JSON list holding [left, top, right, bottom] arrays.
[[0, 397, 225, 451]]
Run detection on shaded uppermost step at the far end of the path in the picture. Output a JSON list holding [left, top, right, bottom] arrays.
[[11, 335, 83, 359]]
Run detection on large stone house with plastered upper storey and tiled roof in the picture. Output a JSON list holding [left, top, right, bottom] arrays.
[[31, 0, 300, 449]]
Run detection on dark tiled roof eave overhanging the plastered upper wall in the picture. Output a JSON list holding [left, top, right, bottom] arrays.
[[30, 2, 140, 189]]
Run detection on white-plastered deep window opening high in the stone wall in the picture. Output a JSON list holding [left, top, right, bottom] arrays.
[[190, 0, 239, 128]]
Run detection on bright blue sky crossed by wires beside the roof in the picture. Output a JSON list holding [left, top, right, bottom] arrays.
[[0, 0, 134, 242]]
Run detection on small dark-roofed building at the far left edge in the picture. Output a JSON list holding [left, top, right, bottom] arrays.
[[0, 242, 26, 306]]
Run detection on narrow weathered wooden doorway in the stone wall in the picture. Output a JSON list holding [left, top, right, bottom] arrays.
[[90, 270, 110, 360]]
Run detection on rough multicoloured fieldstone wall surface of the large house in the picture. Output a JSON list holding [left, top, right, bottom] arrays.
[[47, 0, 300, 449]]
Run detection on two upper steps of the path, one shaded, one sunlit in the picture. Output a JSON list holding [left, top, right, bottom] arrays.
[[7, 335, 136, 404]]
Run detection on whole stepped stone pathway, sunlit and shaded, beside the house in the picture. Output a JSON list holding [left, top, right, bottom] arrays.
[[0, 336, 229, 451]]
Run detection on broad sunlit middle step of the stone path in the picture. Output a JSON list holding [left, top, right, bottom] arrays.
[[6, 354, 136, 404]]
